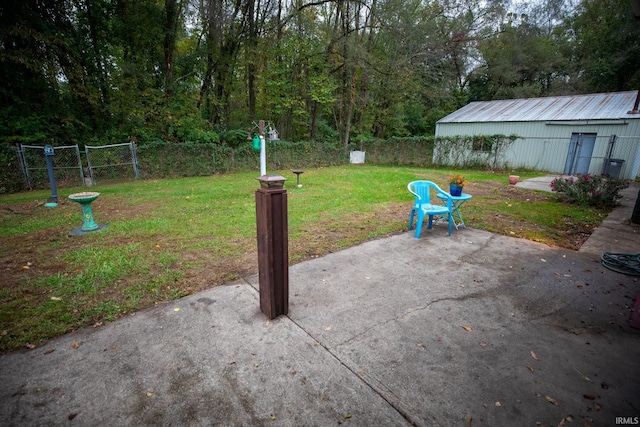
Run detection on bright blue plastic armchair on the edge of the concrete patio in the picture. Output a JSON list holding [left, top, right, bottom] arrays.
[[407, 181, 453, 239]]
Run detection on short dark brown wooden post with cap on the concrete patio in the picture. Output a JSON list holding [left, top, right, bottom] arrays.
[[256, 175, 289, 319]]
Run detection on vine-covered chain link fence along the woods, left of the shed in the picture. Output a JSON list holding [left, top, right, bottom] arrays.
[[0, 137, 434, 192]]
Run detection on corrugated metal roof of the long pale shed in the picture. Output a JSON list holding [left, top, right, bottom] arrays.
[[438, 91, 640, 123]]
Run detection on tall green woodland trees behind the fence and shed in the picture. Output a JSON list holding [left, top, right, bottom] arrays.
[[0, 0, 640, 147]]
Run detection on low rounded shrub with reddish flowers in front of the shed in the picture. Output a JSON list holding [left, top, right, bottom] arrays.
[[551, 174, 629, 208]]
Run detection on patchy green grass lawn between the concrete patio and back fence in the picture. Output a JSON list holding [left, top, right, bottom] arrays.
[[0, 165, 608, 352]]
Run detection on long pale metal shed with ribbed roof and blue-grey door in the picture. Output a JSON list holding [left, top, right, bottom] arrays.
[[434, 91, 640, 179]]
